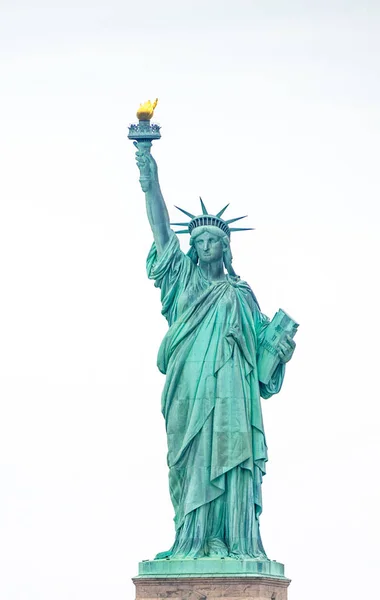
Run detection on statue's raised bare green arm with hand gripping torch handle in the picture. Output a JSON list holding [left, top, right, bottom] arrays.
[[134, 142, 170, 254]]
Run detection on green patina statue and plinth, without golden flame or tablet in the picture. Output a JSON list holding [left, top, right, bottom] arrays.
[[130, 110, 295, 577]]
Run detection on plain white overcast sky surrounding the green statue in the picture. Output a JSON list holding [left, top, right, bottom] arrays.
[[0, 0, 380, 600]]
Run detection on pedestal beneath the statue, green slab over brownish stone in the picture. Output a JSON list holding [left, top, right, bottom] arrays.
[[133, 559, 290, 600]]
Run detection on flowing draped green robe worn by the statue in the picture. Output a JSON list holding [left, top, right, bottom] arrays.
[[147, 234, 284, 557]]
